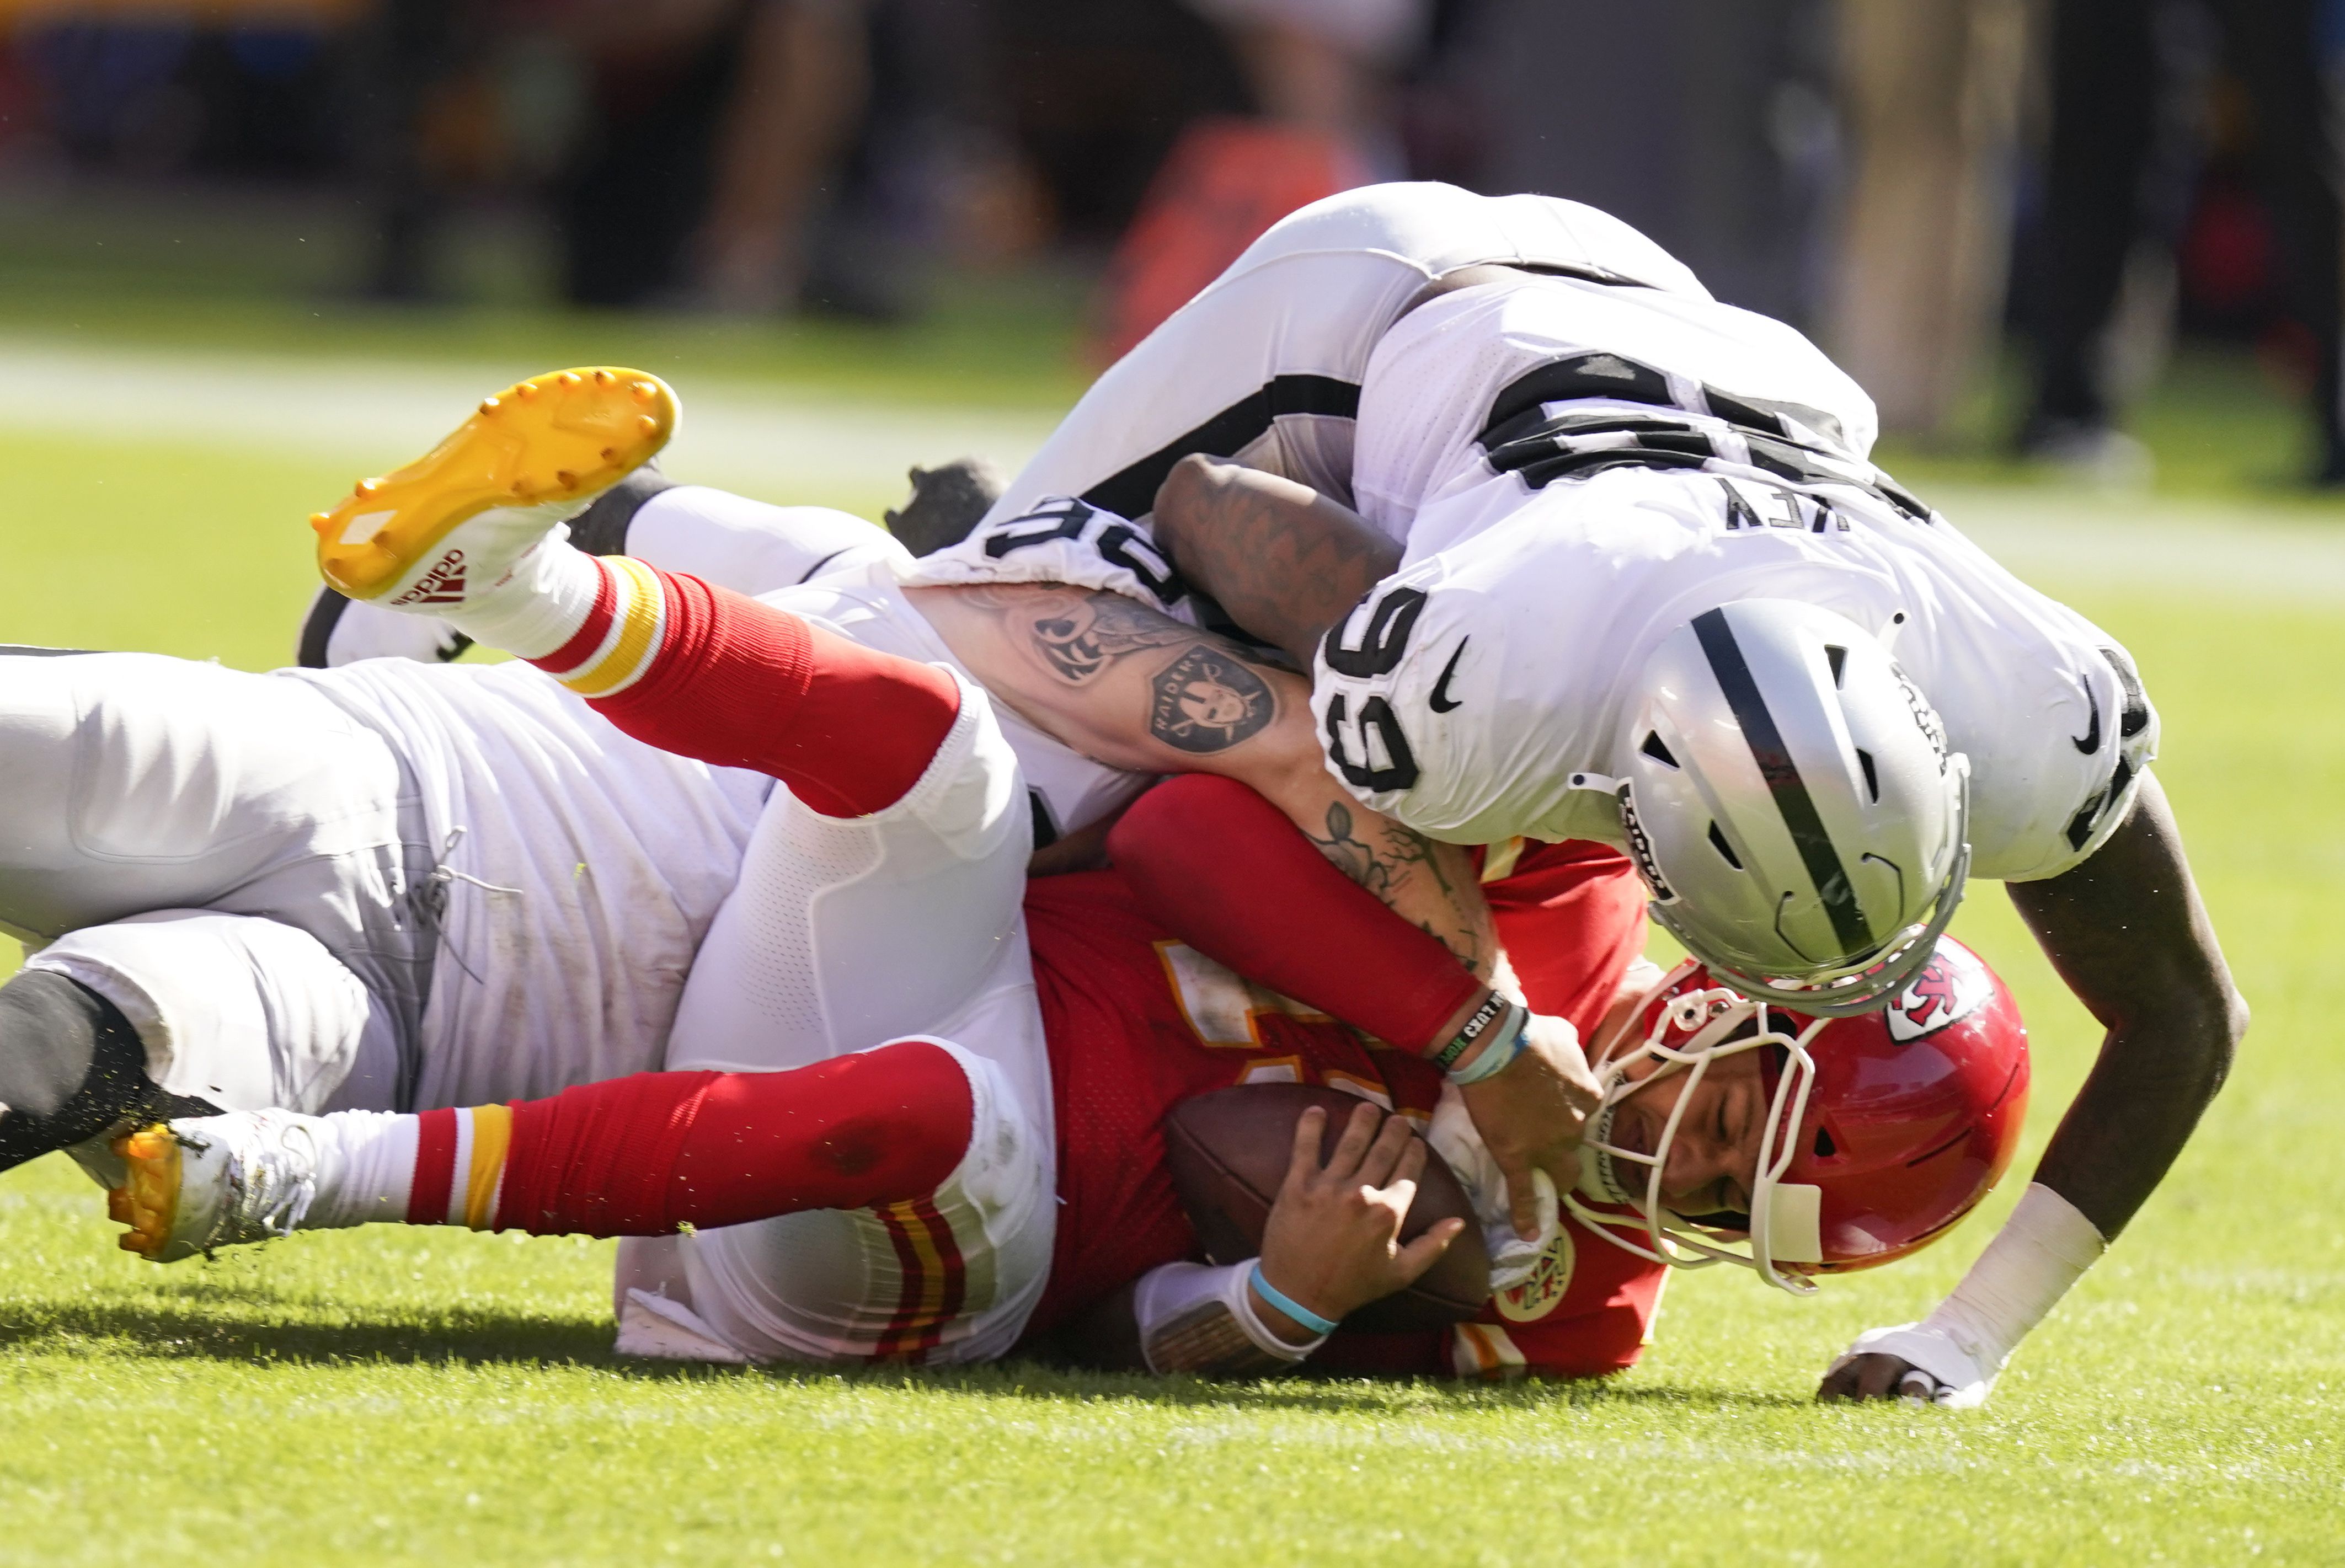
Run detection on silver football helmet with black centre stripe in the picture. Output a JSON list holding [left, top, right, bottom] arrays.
[[1588, 600, 1970, 1017]]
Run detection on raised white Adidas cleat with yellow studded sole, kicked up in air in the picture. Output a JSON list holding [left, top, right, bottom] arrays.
[[309, 366, 678, 612]]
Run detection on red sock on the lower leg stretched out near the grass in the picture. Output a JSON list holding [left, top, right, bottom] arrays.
[[434, 1041, 975, 1235]]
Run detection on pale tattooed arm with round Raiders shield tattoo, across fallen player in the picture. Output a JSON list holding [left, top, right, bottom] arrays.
[[910, 584, 1498, 980]]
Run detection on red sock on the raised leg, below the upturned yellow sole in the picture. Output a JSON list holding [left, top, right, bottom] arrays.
[[535, 563, 961, 816]]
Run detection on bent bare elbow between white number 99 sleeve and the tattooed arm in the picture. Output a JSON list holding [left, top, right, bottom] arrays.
[[1153, 457, 1400, 668]]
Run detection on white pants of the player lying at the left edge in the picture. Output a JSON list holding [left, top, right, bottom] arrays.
[[0, 654, 431, 1109]]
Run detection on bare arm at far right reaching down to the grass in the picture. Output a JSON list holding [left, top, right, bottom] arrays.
[[1818, 773, 2246, 1399]]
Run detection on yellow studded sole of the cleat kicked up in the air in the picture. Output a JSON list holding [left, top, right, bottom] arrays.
[[312, 366, 678, 604]]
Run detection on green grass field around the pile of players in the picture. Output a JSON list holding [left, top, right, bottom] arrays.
[[0, 241, 2345, 1564]]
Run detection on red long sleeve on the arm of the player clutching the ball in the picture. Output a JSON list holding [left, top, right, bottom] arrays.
[[1107, 773, 1482, 1052]]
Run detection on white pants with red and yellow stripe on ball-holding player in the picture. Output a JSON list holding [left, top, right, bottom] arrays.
[[617, 588, 1057, 1362]]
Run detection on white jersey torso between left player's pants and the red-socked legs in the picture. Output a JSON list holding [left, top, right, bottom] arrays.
[[286, 659, 774, 1106]]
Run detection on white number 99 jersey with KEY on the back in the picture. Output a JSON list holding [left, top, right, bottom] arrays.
[[1313, 279, 2157, 879]]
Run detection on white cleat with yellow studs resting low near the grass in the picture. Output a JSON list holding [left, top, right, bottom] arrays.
[[105, 1111, 338, 1264]]
